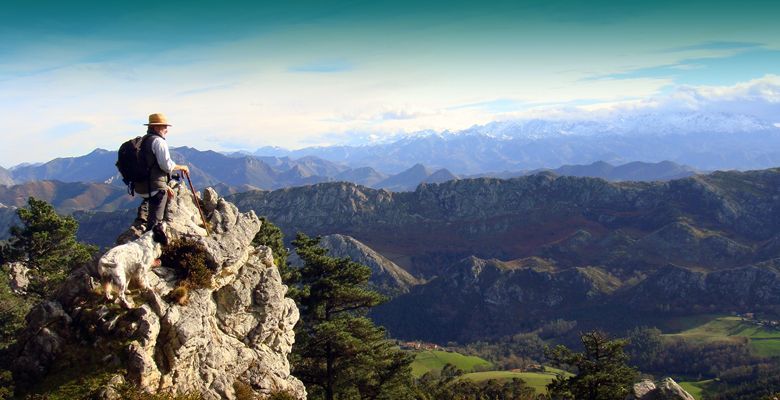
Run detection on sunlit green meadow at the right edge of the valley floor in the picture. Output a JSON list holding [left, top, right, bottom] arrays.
[[664, 316, 780, 357]]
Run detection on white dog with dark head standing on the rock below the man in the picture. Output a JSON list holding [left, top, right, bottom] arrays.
[[98, 224, 168, 308]]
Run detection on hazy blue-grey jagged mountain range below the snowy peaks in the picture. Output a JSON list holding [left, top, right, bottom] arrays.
[[0, 139, 696, 194]]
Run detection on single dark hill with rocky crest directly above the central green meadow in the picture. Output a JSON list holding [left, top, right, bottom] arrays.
[[372, 257, 621, 343]]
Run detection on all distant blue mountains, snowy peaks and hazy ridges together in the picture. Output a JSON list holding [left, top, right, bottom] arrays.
[[6, 112, 780, 185]]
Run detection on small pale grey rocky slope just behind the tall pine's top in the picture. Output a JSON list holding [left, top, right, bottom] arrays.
[[320, 235, 422, 297]]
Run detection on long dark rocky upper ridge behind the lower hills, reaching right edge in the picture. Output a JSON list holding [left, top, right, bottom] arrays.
[[227, 169, 780, 278]]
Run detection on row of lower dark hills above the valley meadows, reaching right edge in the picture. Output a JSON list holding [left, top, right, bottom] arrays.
[[371, 257, 780, 343]]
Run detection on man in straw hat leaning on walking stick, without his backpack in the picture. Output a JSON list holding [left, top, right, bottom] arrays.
[[133, 113, 190, 231]]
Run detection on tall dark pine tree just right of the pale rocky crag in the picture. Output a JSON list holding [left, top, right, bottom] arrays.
[[293, 233, 412, 400]]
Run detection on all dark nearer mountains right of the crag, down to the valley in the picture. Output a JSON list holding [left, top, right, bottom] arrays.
[[6, 168, 780, 342]]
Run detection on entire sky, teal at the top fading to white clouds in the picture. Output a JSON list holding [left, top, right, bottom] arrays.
[[0, 0, 780, 167]]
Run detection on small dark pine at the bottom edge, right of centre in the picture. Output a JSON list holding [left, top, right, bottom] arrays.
[[547, 331, 637, 400]]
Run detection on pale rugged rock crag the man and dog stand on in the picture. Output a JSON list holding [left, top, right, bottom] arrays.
[[14, 187, 306, 399]]
